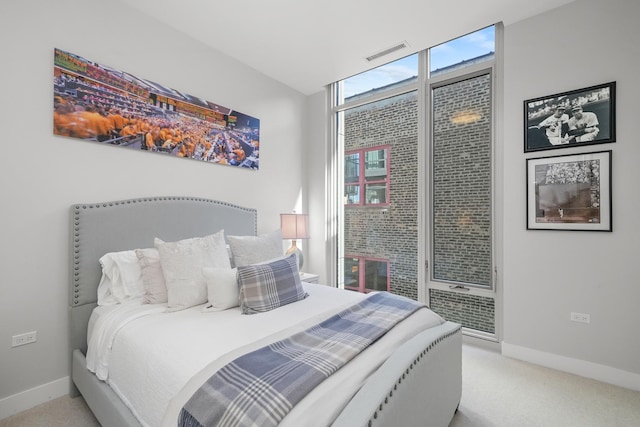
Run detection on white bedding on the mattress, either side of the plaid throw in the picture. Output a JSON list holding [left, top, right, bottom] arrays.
[[87, 283, 443, 427]]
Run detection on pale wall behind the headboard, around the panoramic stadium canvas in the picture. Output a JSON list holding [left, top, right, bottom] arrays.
[[0, 0, 306, 412]]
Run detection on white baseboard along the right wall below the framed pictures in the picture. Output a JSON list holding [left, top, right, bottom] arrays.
[[502, 342, 640, 391]]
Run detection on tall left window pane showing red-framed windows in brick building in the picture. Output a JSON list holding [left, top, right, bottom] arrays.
[[333, 89, 419, 300]]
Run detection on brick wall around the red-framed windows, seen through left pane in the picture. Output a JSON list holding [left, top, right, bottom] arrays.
[[344, 92, 418, 299]]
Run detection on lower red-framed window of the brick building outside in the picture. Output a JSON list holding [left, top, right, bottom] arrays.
[[343, 256, 390, 293]]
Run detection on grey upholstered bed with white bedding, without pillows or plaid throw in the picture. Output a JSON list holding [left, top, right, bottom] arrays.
[[69, 197, 462, 427]]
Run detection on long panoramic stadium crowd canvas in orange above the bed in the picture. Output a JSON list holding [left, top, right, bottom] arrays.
[[53, 49, 260, 170]]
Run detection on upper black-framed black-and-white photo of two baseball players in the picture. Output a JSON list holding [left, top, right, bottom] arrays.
[[524, 82, 616, 153]]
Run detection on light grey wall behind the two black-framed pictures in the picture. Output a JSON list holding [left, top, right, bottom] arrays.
[[503, 0, 640, 389]]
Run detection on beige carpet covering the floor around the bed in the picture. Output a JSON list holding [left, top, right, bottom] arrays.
[[0, 345, 640, 427]]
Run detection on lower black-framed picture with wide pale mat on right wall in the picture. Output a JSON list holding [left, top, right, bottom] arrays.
[[526, 150, 613, 231]]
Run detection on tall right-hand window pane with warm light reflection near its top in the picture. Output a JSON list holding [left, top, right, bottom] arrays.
[[431, 74, 493, 288]]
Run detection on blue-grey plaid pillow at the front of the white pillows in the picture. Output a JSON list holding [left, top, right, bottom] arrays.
[[238, 254, 307, 314]]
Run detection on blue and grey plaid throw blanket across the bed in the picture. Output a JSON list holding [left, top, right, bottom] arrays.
[[178, 292, 424, 427]]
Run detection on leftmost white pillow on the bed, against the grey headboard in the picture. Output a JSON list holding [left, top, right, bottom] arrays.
[[98, 250, 144, 305]]
